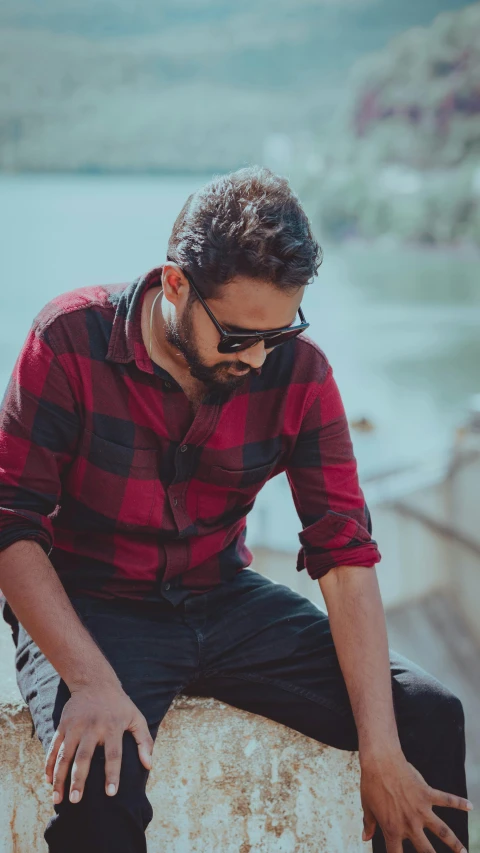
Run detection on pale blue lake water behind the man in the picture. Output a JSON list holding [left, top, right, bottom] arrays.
[[0, 176, 480, 549]]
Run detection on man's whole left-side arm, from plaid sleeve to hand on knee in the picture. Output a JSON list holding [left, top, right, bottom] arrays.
[[0, 320, 153, 802]]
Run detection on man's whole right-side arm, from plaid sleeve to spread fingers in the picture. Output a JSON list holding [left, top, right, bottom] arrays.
[[287, 347, 467, 853]]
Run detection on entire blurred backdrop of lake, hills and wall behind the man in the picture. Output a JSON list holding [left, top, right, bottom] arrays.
[[0, 0, 480, 840]]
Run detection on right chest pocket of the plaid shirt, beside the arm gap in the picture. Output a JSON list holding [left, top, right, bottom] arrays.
[[197, 454, 280, 527]]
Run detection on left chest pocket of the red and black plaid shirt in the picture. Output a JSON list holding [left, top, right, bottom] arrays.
[[68, 430, 159, 529]]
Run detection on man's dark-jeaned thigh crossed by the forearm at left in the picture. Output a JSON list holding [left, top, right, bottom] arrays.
[[15, 597, 198, 751]]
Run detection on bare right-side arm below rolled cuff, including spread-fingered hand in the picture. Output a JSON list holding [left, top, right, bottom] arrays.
[[319, 566, 469, 853]]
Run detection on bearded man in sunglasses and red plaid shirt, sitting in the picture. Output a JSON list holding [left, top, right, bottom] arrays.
[[0, 168, 471, 853]]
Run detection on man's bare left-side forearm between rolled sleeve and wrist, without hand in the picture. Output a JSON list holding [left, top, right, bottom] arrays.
[[0, 540, 119, 691]]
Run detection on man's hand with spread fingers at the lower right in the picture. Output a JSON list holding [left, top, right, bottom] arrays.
[[360, 753, 472, 853]]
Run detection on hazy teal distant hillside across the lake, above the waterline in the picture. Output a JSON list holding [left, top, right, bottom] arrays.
[[0, 0, 464, 171]]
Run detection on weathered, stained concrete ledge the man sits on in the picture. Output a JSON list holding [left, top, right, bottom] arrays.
[[0, 696, 371, 853]]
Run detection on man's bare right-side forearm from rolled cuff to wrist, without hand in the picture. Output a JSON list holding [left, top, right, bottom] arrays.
[[319, 566, 400, 761]]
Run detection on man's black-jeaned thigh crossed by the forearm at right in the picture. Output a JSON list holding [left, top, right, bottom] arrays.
[[189, 572, 460, 750]]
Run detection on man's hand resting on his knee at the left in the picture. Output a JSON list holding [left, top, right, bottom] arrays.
[[45, 683, 153, 803]]
